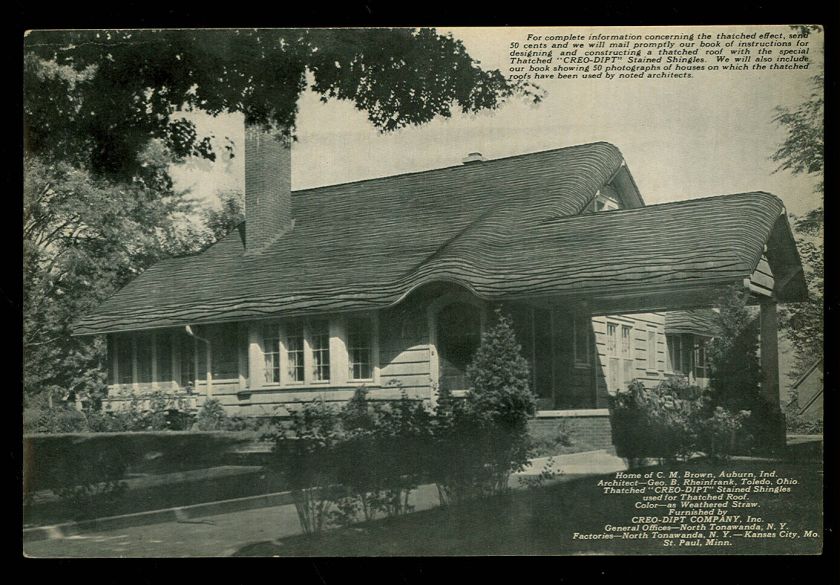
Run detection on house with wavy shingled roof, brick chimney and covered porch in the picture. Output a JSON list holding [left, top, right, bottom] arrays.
[[75, 128, 806, 443]]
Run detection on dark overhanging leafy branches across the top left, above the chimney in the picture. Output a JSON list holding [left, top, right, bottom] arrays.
[[24, 29, 540, 184]]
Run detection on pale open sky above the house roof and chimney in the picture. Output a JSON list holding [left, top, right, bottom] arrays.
[[172, 26, 822, 221]]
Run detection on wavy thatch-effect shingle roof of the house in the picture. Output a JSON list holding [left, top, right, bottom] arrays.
[[75, 143, 808, 334]]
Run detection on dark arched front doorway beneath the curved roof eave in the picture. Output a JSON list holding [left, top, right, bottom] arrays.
[[436, 302, 481, 391]]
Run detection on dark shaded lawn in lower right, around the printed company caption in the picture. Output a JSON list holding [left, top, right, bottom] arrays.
[[237, 460, 823, 556]]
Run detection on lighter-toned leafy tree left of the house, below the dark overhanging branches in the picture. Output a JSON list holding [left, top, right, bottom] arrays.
[[23, 157, 191, 396]]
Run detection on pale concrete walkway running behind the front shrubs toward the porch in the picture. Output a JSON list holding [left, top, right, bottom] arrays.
[[24, 450, 626, 558]]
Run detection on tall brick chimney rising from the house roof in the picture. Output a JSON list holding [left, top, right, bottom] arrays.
[[245, 124, 294, 253]]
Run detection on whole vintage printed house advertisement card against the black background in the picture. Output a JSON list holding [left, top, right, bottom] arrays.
[[22, 23, 825, 559]]
